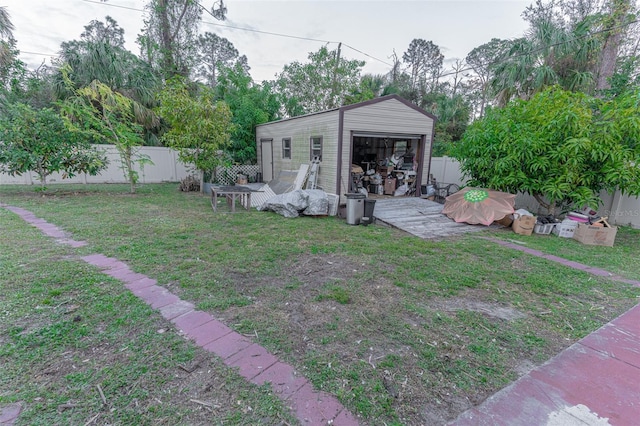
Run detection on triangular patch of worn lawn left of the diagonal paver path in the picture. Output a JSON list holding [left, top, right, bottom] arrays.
[[0, 208, 296, 425]]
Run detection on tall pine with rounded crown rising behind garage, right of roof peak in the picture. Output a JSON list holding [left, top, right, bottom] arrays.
[[402, 38, 444, 92]]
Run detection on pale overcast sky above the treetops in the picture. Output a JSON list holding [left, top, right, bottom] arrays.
[[5, 0, 533, 81]]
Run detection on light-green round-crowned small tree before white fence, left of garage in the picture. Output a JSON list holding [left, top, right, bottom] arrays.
[[157, 76, 233, 192]]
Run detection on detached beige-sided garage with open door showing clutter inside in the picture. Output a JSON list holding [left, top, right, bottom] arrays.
[[256, 95, 435, 197]]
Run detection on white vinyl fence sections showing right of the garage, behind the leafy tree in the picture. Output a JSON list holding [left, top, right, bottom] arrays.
[[431, 157, 640, 228]]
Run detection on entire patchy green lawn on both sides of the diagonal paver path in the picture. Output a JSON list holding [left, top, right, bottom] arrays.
[[0, 184, 640, 425]]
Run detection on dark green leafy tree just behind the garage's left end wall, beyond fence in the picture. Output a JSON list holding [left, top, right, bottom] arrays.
[[215, 63, 280, 164]]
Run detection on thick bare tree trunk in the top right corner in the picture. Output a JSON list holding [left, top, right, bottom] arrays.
[[596, 0, 631, 93]]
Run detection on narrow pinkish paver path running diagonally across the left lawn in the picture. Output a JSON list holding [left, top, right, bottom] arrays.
[[0, 204, 358, 426]]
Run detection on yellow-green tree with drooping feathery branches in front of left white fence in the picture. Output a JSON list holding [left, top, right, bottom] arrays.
[[60, 79, 159, 194]]
